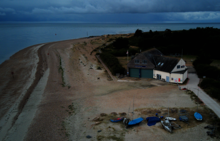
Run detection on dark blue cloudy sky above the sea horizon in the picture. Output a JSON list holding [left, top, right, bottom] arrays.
[[0, 0, 220, 23]]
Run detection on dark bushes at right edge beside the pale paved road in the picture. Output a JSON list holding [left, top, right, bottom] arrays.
[[193, 54, 220, 100]]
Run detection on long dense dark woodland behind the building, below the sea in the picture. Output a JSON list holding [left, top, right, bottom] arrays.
[[129, 27, 220, 59]]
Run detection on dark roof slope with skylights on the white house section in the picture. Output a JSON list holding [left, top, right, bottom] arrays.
[[154, 56, 180, 72]]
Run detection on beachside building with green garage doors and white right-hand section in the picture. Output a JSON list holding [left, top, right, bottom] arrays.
[[127, 48, 188, 83]]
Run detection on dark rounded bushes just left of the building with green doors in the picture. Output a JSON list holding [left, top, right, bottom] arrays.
[[100, 53, 126, 75]]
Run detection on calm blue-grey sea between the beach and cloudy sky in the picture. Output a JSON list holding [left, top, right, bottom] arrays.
[[0, 23, 220, 64]]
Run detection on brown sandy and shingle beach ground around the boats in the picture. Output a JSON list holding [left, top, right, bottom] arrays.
[[0, 35, 218, 141]]
